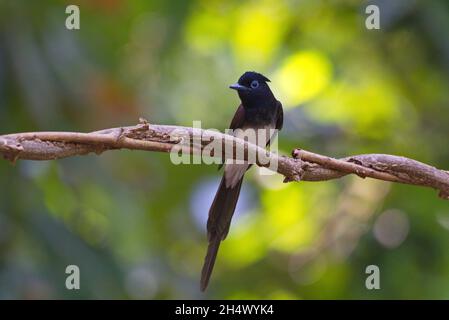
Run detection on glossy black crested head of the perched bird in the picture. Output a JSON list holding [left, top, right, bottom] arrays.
[[229, 71, 275, 108]]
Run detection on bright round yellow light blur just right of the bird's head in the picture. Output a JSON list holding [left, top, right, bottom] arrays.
[[274, 50, 332, 108]]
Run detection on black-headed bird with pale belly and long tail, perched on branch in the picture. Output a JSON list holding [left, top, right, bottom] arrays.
[[201, 72, 283, 291]]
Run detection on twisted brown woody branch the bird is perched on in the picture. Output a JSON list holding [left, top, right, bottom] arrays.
[[0, 120, 449, 200]]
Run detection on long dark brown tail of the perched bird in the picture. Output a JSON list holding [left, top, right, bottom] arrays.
[[201, 177, 243, 291]]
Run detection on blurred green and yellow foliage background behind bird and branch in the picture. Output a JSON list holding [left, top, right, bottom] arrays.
[[0, 0, 449, 299]]
